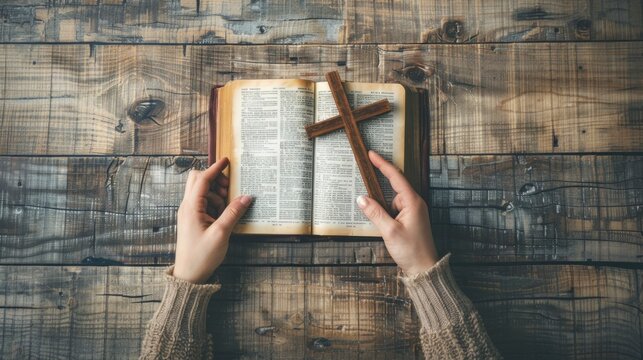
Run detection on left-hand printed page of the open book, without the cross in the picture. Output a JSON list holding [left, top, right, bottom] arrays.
[[226, 80, 315, 234]]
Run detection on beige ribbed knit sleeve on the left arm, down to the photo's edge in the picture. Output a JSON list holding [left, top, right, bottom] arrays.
[[140, 266, 221, 359]]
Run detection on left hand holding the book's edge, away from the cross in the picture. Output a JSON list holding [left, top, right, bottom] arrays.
[[174, 158, 252, 284]]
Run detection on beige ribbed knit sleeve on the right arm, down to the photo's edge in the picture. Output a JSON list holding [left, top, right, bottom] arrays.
[[401, 254, 502, 359]]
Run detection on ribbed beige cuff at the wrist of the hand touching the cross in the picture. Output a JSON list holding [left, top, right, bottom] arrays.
[[400, 254, 473, 332]]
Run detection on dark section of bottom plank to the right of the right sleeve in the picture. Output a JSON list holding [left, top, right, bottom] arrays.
[[455, 265, 642, 359]]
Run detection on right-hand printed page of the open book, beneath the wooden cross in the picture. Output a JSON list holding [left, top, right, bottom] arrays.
[[313, 82, 405, 236]]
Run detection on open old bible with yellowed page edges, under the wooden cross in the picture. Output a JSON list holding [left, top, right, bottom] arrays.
[[209, 79, 427, 236]]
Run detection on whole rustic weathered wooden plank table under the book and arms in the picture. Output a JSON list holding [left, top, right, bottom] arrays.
[[0, 0, 643, 359]]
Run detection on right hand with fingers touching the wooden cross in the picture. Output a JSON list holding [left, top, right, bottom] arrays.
[[357, 150, 438, 276]]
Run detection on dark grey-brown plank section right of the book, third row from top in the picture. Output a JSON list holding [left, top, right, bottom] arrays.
[[429, 155, 643, 262]]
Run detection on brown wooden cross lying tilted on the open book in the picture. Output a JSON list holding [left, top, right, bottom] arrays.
[[306, 71, 391, 211]]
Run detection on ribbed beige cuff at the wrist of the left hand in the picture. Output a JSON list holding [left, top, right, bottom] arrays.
[[154, 265, 221, 338]]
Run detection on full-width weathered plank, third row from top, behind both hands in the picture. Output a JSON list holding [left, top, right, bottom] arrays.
[[0, 155, 643, 265]]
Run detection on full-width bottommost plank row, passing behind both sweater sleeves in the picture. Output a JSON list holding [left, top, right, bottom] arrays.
[[0, 265, 643, 359]]
